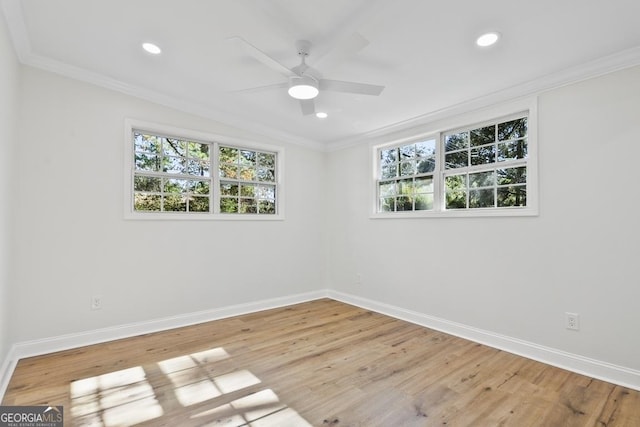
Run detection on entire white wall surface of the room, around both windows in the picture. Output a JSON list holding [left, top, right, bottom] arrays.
[[0, 32, 640, 388]]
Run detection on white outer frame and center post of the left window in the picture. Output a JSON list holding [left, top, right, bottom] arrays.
[[124, 118, 285, 221]]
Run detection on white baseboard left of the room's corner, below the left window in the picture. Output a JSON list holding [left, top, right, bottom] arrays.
[[0, 290, 327, 401]]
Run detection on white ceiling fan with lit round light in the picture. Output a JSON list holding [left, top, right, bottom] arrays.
[[232, 36, 384, 115]]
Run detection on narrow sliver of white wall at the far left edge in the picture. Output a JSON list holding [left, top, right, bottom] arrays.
[[0, 12, 20, 376]]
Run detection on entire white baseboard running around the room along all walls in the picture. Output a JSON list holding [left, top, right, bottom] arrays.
[[0, 289, 640, 401]]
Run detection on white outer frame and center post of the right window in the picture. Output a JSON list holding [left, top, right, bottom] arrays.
[[370, 97, 539, 219]]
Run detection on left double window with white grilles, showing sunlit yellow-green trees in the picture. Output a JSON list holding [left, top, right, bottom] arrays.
[[125, 122, 283, 219]]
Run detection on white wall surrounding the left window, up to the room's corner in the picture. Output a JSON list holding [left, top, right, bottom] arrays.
[[11, 67, 326, 342]]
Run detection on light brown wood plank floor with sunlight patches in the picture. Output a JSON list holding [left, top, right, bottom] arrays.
[[2, 299, 640, 427]]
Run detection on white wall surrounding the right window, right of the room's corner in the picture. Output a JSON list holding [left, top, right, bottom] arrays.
[[328, 67, 640, 370]]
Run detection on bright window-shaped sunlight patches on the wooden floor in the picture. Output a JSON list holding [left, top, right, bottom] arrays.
[[70, 348, 311, 427]]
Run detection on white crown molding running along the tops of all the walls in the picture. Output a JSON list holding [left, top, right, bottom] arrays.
[[5, 0, 640, 152]]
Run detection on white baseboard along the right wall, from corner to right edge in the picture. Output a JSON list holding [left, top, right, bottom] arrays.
[[327, 290, 640, 391]]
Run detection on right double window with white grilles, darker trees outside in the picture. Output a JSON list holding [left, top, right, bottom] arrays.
[[374, 112, 537, 217]]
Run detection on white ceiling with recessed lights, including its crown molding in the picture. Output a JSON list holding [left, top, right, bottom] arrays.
[[0, 0, 640, 147]]
